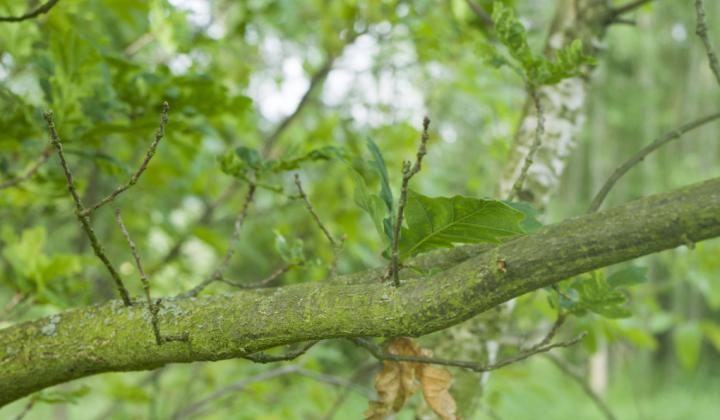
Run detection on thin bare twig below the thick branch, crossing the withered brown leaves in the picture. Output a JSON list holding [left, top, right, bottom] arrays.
[[350, 332, 587, 372]]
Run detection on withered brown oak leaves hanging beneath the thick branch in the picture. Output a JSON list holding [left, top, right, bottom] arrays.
[[365, 337, 457, 420]]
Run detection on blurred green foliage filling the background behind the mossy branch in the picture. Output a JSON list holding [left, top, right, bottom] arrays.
[[0, 0, 720, 419]]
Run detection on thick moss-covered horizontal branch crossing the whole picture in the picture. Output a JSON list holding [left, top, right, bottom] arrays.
[[0, 178, 720, 406]]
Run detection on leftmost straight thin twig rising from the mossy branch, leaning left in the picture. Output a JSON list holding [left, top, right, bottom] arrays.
[[43, 111, 132, 306]]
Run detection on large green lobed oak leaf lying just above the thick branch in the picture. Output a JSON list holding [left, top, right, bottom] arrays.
[[399, 190, 524, 259]]
